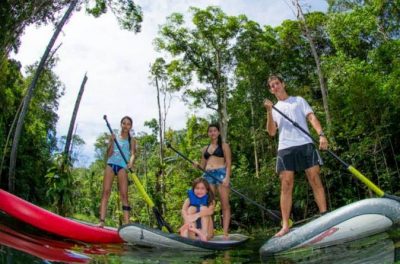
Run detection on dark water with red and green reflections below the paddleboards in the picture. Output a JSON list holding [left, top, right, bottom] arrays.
[[0, 212, 400, 264]]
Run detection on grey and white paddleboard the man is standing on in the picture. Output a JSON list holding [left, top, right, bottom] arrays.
[[260, 198, 400, 256]]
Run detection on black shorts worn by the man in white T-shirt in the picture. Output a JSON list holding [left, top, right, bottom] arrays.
[[276, 143, 323, 173]]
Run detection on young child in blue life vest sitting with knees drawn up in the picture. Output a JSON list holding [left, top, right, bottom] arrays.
[[180, 178, 215, 241]]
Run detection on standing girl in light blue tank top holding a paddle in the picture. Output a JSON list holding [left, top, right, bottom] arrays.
[[99, 116, 136, 227]]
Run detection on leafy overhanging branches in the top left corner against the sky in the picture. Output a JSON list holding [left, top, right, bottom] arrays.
[[0, 0, 143, 59]]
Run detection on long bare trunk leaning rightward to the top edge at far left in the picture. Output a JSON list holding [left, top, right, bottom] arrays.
[[8, 0, 78, 192]]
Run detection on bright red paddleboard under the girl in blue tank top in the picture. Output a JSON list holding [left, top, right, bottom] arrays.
[[0, 189, 123, 243]]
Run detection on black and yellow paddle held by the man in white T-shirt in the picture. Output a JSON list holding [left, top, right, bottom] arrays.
[[272, 105, 400, 202]]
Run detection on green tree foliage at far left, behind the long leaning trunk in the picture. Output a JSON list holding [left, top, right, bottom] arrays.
[[0, 59, 63, 202]]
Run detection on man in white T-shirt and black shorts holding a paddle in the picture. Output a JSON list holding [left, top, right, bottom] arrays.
[[264, 75, 328, 237]]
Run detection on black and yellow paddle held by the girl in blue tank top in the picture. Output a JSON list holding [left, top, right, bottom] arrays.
[[103, 115, 173, 233]]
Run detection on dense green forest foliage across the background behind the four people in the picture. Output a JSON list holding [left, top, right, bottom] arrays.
[[0, 3, 400, 233]]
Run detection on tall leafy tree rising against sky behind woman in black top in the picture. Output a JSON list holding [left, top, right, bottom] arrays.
[[156, 7, 244, 140]]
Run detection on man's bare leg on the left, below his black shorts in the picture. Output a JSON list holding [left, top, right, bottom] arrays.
[[275, 171, 294, 237]]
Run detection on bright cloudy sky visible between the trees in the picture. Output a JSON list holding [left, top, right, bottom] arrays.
[[11, 0, 328, 166]]
